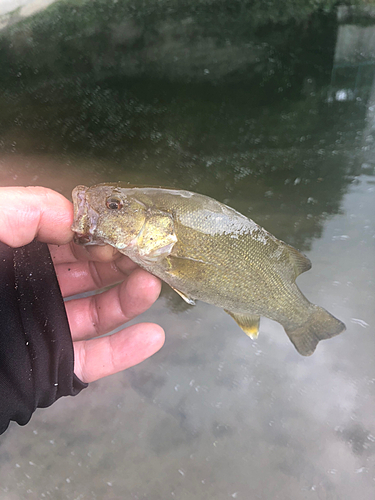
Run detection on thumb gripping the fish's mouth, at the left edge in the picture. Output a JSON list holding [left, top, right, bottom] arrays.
[[0, 186, 73, 247]]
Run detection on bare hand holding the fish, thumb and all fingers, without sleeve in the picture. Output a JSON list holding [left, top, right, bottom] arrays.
[[0, 187, 164, 382]]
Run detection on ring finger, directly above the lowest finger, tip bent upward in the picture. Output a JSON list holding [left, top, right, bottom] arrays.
[[65, 269, 161, 340]]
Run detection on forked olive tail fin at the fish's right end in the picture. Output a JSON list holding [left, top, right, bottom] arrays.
[[285, 305, 346, 356]]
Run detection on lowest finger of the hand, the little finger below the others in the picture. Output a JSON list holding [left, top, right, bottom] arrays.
[[73, 323, 165, 382]]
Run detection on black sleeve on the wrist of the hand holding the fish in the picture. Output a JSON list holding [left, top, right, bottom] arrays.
[[0, 241, 87, 434]]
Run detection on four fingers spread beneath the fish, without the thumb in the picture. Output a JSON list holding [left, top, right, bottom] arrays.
[[50, 243, 164, 382]]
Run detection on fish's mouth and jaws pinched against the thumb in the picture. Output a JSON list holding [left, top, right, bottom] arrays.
[[71, 186, 105, 245]]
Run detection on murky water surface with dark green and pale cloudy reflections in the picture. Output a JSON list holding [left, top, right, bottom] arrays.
[[0, 0, 375, 500]]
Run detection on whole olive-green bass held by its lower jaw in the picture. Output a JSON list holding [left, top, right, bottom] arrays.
[[72, 182, 345, 356]]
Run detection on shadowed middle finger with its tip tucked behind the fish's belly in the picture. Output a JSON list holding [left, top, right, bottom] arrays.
[[55, 257, 138, 297]]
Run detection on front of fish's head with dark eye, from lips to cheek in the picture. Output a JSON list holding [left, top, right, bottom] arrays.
[[72, 184, 147, 251]]
